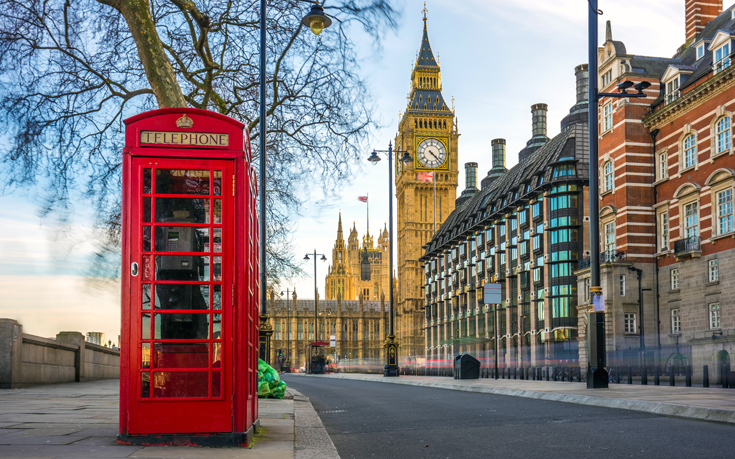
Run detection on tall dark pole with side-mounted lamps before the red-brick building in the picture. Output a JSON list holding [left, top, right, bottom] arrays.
[[587, 0, 651, 389]]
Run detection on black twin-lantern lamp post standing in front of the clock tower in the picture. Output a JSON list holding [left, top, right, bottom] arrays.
[[368, 142, 413, 377]]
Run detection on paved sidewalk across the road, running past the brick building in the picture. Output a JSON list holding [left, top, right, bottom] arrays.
[[298, 373, 735, 424]]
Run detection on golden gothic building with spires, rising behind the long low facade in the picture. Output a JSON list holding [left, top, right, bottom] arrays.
[[325, 212, 390, 301]]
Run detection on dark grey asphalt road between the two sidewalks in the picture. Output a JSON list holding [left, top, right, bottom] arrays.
[[281, 374, 735, 459]]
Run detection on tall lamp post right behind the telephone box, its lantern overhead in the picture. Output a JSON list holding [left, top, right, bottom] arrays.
[[258, 0, 332, 363]]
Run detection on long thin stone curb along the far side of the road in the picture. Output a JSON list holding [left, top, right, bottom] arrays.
[[310, 375, 735, 424]]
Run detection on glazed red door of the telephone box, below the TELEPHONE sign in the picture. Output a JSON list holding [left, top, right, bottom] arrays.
[[123, 157, 234, 435]]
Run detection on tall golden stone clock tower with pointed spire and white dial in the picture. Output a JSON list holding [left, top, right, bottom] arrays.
[[394, 8, 459, 365]]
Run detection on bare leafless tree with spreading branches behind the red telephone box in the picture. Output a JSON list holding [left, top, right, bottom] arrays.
[[0, 0, 397, 288]]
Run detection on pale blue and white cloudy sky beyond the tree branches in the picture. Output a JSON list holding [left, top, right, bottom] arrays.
[[0, 0, 684, 342]]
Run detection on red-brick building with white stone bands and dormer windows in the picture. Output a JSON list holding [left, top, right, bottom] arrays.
[[577, 0, 735, 381]]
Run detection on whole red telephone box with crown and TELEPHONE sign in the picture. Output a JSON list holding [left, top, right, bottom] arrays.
[[118, 108, 259, 446]]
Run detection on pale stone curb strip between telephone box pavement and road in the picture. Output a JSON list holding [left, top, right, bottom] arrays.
[[286, 387, 340, 459]]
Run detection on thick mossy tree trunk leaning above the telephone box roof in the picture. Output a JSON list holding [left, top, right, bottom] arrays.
[[114, 0, 187, 108]]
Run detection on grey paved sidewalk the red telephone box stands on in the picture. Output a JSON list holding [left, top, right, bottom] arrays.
[[0, 380, 339, 459]]
